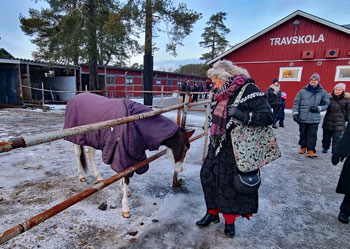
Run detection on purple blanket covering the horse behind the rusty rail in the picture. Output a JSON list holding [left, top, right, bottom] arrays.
[[64, 93, 179, 176]]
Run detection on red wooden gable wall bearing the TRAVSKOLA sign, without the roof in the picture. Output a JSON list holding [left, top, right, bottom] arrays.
[[222, 16, 350, 108]]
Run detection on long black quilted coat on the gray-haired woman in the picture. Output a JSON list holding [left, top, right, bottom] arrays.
[[200, 81, 273, 215]]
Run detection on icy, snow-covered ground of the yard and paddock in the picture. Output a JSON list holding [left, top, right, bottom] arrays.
[[0, 99, 350, 249]]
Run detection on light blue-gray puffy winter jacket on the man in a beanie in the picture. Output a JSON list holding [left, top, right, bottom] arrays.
[[293, 84, 330, 124]]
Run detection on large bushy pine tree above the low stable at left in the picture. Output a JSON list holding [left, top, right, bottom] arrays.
[[20, 0, 140, 90]]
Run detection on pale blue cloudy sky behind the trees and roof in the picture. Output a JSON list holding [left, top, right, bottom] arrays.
[[0, 0, 350, 70]]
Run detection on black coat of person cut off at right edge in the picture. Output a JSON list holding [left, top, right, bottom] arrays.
[[334, 125, 350, 195]]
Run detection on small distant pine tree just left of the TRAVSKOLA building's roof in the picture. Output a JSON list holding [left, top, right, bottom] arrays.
[[199, 12, 230, 61]]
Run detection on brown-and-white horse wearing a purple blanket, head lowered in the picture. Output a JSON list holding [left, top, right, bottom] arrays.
[[64, 93, 194, 218]]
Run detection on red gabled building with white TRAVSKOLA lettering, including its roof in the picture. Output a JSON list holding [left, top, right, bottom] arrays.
[[209, 10, 350, 108]]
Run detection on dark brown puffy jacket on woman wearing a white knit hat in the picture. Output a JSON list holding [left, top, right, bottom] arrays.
[[322, 93, 350, 131]]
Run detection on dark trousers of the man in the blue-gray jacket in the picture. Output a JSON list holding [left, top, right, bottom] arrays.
[[299, 123, 318, 151]]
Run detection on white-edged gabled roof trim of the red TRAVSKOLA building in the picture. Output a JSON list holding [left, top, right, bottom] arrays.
[[208, 10, 350, 65]]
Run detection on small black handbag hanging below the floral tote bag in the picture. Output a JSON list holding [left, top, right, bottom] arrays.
[[233, 170, 261, 194]]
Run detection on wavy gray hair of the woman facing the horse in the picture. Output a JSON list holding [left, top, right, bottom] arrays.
[[207, 60, 250, 81]]
